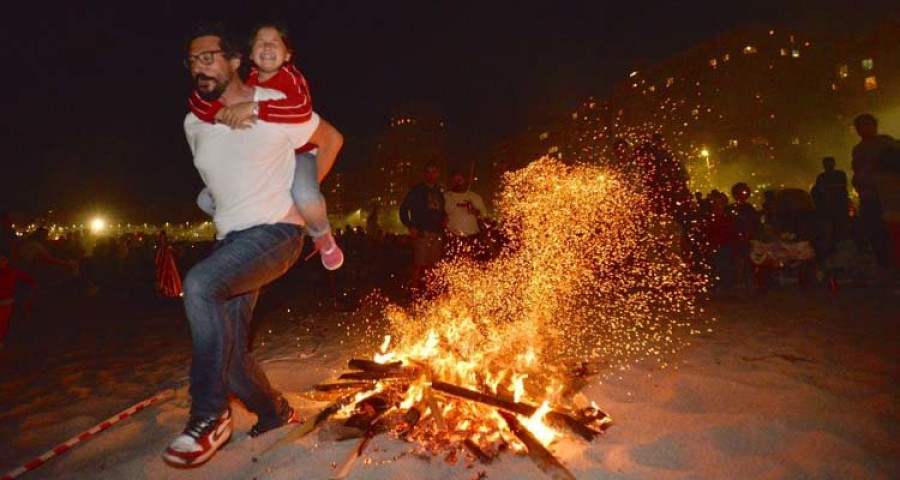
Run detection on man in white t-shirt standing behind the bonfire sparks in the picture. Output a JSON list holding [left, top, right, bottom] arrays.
[[444, 171, 487, 255]]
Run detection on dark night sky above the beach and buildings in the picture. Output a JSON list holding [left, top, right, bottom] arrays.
[[0, 0, 890, 220]]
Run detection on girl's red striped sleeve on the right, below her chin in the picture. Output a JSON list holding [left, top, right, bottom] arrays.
[[259, 65, 312, 123]]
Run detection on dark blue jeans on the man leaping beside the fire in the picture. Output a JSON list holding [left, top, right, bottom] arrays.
[[184, 223, 303, 425]]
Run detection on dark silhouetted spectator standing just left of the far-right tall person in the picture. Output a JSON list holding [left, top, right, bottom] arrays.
[[810, 157, 850, 260]]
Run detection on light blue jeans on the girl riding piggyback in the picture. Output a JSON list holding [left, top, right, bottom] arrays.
[[197, 152, 331, 239]]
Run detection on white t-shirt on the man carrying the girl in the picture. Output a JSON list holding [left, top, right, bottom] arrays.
[[184, 87, 319, 239]]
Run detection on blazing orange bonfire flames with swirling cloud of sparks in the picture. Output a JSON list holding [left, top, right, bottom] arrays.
[[289, 158, 704, 476]]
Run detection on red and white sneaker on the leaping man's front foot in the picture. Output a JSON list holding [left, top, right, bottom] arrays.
[[163, 409, 233, 468]]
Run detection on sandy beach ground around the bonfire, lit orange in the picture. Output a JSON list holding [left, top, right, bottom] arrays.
[[0, 286, 900, 480]]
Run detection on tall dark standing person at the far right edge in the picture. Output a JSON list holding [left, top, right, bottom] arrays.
[[851, 113, 898, 268]]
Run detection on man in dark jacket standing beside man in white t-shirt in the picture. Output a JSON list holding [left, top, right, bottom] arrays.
[[400, 163, 446, 289]]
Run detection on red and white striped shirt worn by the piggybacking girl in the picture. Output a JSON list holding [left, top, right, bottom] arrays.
[[188, 63, 316, 153]]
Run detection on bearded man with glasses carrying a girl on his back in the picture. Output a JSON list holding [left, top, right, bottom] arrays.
[[163, 26, 340, 467]]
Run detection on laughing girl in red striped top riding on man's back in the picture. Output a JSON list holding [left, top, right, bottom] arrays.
[[188, 24, 344, 270]]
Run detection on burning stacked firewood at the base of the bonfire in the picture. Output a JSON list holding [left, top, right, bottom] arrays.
[[269, 359, 612, 479]]
